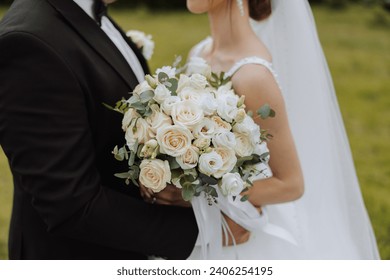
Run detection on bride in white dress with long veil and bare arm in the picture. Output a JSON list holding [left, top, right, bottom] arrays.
[[187, 0, 379, 259]]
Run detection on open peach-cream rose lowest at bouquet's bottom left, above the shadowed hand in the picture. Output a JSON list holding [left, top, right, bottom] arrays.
[[139, 159, 172, 193]]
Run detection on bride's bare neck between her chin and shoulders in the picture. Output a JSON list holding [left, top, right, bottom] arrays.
[[209, 4, 253, 55]]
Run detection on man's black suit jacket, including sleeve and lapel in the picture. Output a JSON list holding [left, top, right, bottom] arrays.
[[0, 0, 198, 259]]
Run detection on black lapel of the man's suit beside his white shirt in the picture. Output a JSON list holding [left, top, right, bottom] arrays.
[[46, 0, 138, 89]]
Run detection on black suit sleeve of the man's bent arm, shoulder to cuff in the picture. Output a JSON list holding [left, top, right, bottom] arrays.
[[0, 33, 198, 259]]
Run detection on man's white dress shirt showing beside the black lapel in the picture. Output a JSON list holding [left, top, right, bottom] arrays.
[[73, 0, 145, 82]]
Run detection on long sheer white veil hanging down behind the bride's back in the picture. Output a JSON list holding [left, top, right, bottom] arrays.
[[252, 0, 379, 259]]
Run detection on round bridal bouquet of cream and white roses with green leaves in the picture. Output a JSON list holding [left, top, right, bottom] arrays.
[[107, 59, 275, 203]]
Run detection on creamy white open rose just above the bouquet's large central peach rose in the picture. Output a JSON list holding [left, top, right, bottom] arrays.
[[172, 101, 204, 129]]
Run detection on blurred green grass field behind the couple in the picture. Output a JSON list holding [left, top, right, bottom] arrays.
[[0, 6, 390, 259]]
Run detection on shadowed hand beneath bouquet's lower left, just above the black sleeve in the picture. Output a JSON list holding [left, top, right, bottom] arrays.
[[138, 182, 191, 207]]
